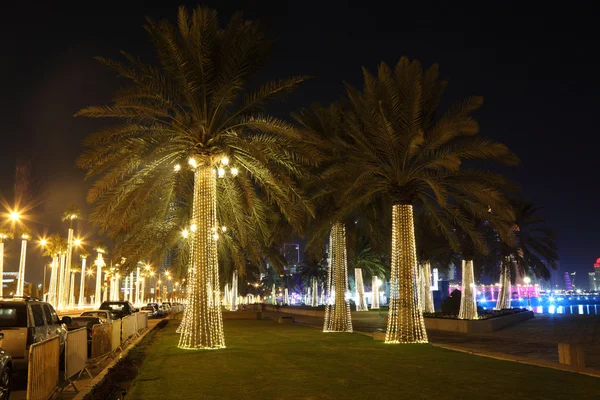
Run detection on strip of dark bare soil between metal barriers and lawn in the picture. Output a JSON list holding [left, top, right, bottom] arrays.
[[84, 320, 169, 400]]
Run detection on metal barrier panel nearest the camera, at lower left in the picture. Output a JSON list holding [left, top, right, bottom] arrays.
[[27, 336, 60, 400]]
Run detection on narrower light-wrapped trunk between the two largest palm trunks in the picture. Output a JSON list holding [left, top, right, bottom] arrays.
[[323, 222, 352, 332]]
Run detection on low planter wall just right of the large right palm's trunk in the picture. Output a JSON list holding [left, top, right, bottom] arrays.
[[425, 311, 533, 333]]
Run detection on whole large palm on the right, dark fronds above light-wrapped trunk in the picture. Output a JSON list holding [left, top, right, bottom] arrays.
[[329, 57, 517, 343]]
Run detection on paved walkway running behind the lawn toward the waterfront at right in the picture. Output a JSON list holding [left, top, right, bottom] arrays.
[[263, 312, 600, 371]]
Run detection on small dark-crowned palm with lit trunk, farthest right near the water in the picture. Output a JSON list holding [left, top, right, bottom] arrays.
[[491, 199, 558, 309]]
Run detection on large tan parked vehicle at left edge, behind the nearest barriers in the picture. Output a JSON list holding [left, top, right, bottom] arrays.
[[0, 297, 71, 370]]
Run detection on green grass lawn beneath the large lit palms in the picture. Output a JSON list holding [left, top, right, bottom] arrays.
[[127, 320, 600, 400]]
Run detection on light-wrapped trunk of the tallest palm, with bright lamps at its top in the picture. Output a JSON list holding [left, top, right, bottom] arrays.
[[179, 156, 225, 349]]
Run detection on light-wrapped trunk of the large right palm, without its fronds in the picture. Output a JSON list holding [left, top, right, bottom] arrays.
[[385, 204, 428, 343]]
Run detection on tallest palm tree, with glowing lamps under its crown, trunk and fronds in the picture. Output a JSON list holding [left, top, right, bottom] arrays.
[[77, 7, 319, 349]]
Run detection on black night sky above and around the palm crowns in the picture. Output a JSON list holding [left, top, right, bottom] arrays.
[[0, 0, 600, 287]]
